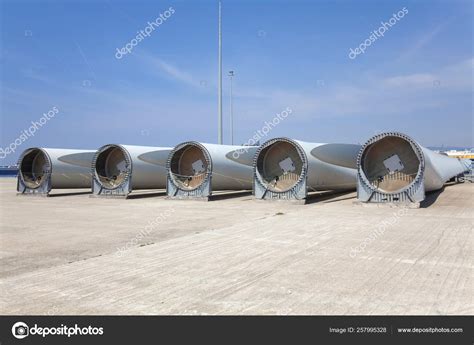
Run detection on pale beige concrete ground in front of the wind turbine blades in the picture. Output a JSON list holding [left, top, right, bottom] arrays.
[[0, 178, 474, 315]]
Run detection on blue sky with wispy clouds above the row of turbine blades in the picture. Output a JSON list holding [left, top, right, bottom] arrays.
[[0, 0, 474, 164]]
